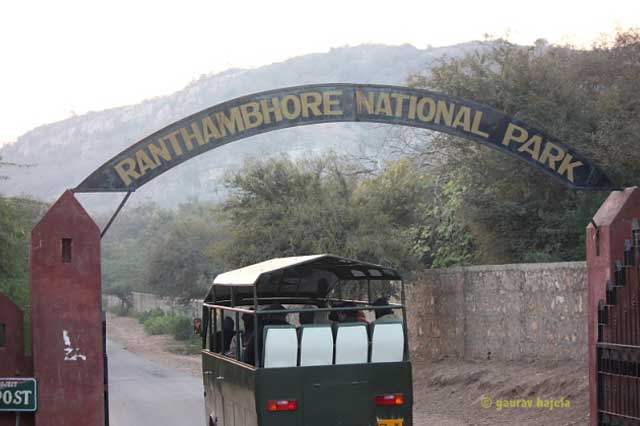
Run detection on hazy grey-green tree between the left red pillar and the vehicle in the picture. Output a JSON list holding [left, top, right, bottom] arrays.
[[103, 202, 221, 302]]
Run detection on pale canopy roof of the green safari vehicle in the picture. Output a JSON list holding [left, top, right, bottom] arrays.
[[205, 254, 402, 305]]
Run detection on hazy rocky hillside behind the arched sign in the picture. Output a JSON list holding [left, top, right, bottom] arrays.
[[0, 43, 478, 209]]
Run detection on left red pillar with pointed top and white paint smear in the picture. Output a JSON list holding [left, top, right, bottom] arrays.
[[31, 191, 104, 426]]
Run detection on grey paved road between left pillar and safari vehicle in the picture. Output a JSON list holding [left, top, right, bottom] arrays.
[[107, 340, 205, 426]]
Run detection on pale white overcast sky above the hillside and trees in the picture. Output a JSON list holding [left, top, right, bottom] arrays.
[[0, 0, 640, 145]]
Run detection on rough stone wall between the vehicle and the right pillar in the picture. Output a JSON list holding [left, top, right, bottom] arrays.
[[407, 262, 588, 363]]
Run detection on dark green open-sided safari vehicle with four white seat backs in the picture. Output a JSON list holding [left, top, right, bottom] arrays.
[[202, 255, 413, 426]]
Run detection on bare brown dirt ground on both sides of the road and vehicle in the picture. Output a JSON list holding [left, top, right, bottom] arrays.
[[107, 316, 589, 426]]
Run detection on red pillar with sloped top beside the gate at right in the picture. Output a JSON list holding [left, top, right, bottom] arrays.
[[587, 187, 640, 426]]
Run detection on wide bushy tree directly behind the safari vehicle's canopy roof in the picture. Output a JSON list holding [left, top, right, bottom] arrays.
[[212, 155, 465, 270]]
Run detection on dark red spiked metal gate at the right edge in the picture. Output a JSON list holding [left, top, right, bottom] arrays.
[[590, 188, 640, 426]]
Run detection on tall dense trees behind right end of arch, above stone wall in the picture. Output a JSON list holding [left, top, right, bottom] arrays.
[[410, 32, 640, 263]]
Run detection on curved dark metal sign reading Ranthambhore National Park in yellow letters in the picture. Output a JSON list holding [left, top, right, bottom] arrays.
[[74, 84, 615, 192]]
